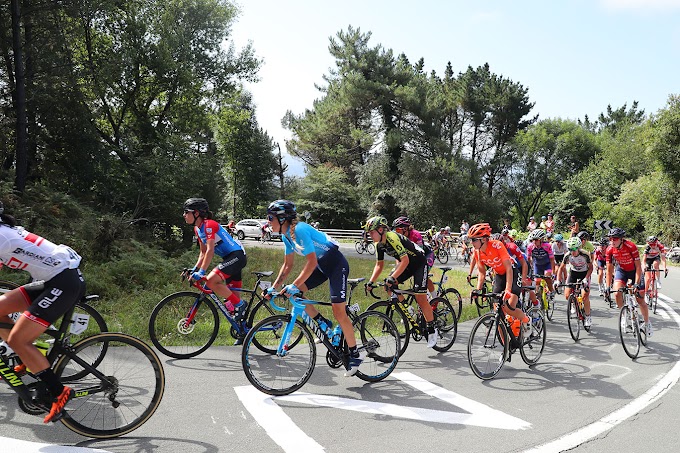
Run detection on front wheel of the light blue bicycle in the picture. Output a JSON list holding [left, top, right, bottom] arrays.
[[241, 314, 316, 396]]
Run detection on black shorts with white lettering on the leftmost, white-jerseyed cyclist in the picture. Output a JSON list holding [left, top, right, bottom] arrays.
[[21, 269, 85, 328]]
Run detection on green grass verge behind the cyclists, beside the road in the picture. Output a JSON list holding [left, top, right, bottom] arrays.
[[0, 242, 477, 344]]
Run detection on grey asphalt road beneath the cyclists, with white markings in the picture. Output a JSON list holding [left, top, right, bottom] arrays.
[[0, 242, 680, 453]]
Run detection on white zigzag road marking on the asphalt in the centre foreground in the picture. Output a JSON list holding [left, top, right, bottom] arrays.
[[234, 372, 531, 452]]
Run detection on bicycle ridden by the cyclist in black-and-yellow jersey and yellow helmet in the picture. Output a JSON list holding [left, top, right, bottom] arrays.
[[365, 283, 458, 356]]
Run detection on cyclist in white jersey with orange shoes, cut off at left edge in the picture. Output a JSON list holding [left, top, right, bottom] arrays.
[[0, 203, 85, 423]]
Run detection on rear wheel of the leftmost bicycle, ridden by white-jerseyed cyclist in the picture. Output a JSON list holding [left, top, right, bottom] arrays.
[[54, 333, 165, 439]]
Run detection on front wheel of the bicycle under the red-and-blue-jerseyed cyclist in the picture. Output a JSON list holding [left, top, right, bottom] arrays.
[[149, 291, 220, 359]]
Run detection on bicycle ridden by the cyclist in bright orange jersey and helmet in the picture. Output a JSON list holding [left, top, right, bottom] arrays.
[[468, 290, 546, 380]]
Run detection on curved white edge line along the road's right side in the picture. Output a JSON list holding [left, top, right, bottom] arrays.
[[526, 294, 680, 453]]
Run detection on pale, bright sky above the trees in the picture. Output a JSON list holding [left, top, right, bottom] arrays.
[[232, 0, 680, 175]]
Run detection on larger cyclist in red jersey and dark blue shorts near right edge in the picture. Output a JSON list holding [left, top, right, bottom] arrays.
[[605, 228, 652, 337]]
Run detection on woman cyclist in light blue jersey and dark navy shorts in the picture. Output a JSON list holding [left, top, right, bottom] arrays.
[[267, 200, 366, 376]]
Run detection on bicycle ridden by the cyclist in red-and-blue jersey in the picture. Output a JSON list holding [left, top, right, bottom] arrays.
[[149, 269, 275, 359]]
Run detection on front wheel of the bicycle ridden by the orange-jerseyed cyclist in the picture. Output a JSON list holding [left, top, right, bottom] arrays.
[[468, 313, 509, 380]]
